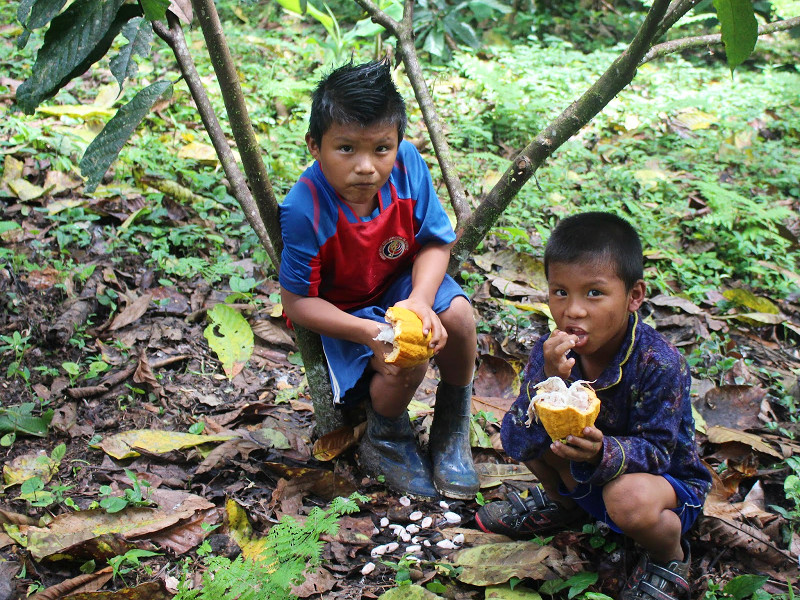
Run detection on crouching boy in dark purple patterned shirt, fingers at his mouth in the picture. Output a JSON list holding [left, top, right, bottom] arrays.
[[475, 212, 711, 600]]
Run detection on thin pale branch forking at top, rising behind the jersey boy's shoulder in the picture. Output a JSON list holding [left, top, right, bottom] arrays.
[[356, 0, 470, 229]]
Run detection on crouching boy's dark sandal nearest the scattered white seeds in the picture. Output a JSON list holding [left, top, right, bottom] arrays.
[[475, 487, 581, 540]]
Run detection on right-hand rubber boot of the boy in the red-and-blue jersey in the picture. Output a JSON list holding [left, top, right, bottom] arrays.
[[429, 381, 480, 500]]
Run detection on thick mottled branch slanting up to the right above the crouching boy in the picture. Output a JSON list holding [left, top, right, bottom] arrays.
[[450, 0, 670, 271]]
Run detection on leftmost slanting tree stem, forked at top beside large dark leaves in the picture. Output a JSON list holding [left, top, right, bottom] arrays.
[[153, 12, 280, 266]]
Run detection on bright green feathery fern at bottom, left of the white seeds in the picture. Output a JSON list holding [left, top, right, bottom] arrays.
[[174, 494, 367, 600]]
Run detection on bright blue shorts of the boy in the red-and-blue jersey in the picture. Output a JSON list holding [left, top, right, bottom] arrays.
[[321, 269, 467, 404]]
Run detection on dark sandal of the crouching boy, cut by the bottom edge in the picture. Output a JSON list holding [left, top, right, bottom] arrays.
[[620, 539, 691, 600]]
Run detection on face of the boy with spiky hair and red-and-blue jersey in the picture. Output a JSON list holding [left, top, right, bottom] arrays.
[[306, 123, 399, 216]]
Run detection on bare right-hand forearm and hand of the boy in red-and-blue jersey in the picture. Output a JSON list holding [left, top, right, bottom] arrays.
[[397, 243, 452, 350]]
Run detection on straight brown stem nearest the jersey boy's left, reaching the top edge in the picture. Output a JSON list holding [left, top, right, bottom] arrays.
[[192, 0, 283, 258]]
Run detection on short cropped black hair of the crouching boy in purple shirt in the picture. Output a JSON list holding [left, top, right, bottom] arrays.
[[544, 212, 644, 291]]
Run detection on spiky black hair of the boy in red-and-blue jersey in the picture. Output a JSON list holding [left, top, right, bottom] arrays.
[[308, 58, 407, 146]]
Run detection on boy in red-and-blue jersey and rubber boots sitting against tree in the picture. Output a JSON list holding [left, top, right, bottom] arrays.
[[280, 61, 478, 499]]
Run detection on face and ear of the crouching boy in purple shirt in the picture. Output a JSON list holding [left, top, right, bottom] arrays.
[[547, 260, 645, 369]]
